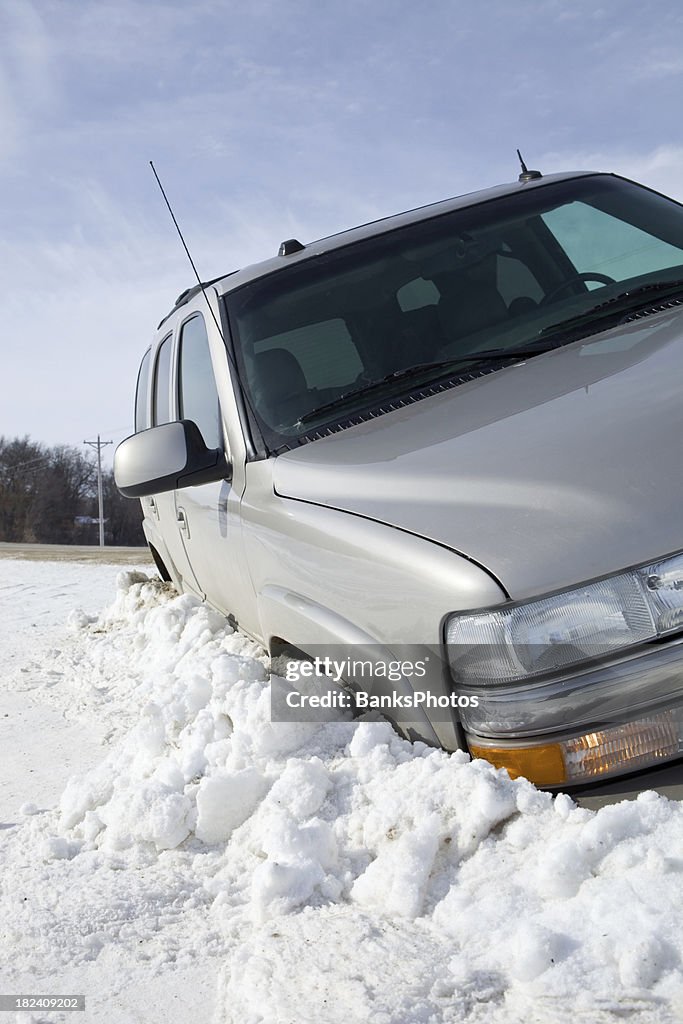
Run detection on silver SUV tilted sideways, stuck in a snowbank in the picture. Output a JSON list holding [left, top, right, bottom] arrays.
[[115, 172, 683, 787]]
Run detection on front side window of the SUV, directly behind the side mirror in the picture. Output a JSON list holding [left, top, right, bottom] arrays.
[[178, 315, 223, 449]]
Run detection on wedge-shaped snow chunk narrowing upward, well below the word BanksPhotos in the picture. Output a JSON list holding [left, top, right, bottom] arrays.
[[351, 814, 442, 919]]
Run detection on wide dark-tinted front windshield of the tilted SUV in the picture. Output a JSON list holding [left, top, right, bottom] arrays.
[[225, 175, 683, 450]]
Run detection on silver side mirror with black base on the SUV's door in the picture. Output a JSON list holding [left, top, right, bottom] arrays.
[[114, 420, 230, 498]]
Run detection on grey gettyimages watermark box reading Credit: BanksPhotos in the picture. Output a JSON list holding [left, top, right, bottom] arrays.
[[271, 653, 479, 722]]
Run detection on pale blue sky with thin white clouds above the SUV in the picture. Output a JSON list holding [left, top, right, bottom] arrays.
[[0, 0, 683, 452]]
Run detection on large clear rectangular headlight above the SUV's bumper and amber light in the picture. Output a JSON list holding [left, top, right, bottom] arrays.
[[445, 554, 683, 687]]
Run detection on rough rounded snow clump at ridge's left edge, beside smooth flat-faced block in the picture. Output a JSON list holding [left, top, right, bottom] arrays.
[[98, 779, 194, 850]]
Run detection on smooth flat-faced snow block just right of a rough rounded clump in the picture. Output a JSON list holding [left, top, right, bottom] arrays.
[[195, 768, 268, 843]]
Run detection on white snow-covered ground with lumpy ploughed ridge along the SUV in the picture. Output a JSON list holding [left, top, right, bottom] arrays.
[[0, 560, 683, 1024]]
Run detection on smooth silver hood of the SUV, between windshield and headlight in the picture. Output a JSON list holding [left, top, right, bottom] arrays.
[[273, 311, 683, 600]]
